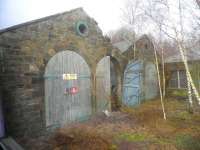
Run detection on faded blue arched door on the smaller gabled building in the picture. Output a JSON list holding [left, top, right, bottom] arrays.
[[122, 61, 143, 106]]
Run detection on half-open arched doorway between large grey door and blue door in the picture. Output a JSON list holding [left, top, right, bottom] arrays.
[[96, 56, 121, 112]]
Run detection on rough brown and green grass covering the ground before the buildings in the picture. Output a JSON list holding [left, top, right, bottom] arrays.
[[51, 99, 200, 150]]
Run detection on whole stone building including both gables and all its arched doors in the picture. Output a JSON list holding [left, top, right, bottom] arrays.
[[0, 8, 157, 136]]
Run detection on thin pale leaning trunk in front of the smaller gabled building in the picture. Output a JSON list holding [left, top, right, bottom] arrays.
[[154, 49, 166, 120]]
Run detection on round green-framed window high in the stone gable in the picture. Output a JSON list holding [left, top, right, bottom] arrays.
[[76, 21, 88, 36]]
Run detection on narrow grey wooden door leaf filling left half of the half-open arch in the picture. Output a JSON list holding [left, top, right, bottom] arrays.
[[96, 56, 111, 112]]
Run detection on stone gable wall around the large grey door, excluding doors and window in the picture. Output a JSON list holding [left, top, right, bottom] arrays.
[[0, 8, 125, 136]]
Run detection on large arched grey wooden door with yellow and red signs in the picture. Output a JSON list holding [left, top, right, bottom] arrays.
[[45, 51, 91, 126]]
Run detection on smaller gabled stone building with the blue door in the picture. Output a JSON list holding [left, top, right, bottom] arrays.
[[114, 35, 158, 106]]
